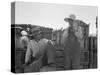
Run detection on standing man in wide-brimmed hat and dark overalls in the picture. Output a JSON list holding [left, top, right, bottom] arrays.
[[61, 14, 82, 70]]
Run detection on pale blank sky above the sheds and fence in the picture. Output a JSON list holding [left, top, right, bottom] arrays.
[[15, 2, 98, 34]]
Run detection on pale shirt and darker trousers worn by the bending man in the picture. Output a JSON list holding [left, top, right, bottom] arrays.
[[25, 39, 55, 72]]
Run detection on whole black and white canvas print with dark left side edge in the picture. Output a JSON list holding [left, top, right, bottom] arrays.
[[11, 1, 98, 73]]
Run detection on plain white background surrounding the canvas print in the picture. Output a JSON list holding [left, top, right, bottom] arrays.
[[0, 0, 100, 75]]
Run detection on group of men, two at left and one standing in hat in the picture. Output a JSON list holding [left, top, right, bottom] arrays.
[[21, 15, 83, 72]]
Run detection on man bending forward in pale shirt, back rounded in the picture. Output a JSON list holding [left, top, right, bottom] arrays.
[[25, 27, 55, 72]]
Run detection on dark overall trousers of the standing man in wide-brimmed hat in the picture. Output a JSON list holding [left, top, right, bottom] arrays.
[[64, 37, 81, 70]]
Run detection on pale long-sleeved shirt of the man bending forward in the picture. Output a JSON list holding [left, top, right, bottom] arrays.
[[25, 39, 48, 62]]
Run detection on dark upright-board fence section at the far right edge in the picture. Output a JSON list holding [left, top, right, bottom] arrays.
[[89, 36, 97, 68]]
